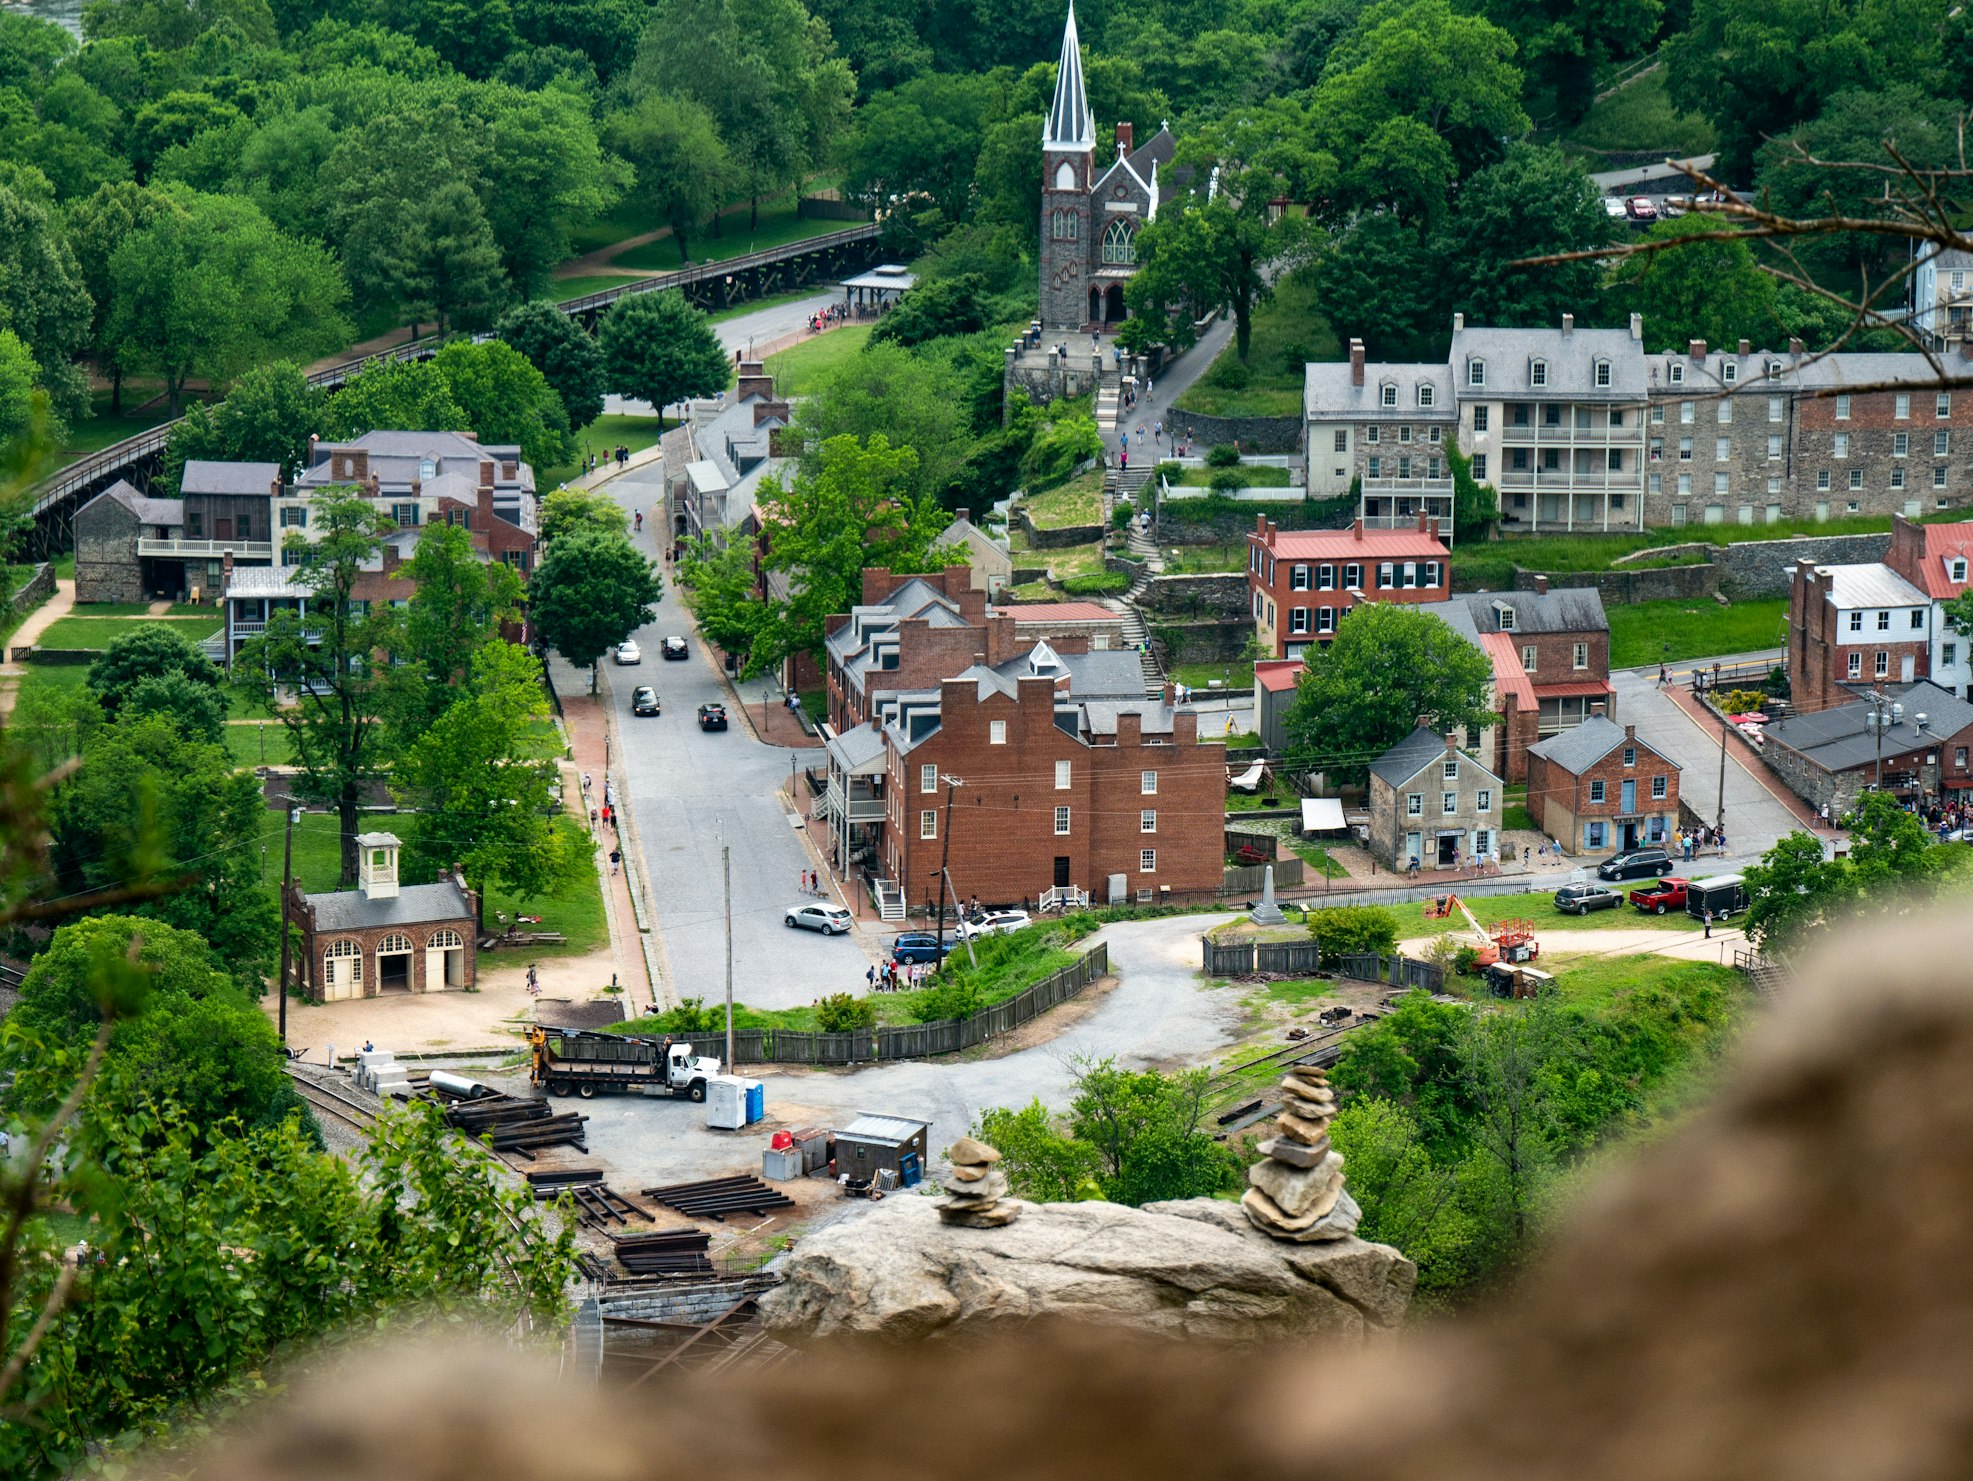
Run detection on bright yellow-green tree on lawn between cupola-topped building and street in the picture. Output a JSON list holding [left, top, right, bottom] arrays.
[[395, 641, 590, 917]]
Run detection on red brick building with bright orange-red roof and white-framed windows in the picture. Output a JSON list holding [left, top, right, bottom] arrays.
[[1247, 515, 1452, 659]]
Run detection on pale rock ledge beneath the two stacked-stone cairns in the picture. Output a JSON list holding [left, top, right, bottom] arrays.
[[760, 1195, 1419, 1343]]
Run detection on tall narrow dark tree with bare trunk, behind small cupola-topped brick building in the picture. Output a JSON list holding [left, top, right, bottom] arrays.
[[233, 489, 401, 885]]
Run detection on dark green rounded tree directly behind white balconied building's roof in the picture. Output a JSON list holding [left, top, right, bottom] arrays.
[[1438, 144, 1610, 325]]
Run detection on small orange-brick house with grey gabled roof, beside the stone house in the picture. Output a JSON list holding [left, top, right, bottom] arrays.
[[1527, 706, 1679, 854]]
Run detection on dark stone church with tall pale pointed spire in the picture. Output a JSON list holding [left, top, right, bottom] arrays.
[[1042, 4, 1176, 331]]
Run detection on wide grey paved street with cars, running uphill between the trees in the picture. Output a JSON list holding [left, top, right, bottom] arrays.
[[604, 451, 870, 1008]]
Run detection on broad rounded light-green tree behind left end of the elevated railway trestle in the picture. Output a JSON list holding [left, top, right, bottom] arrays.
[[105, 193, 353, 410]]
